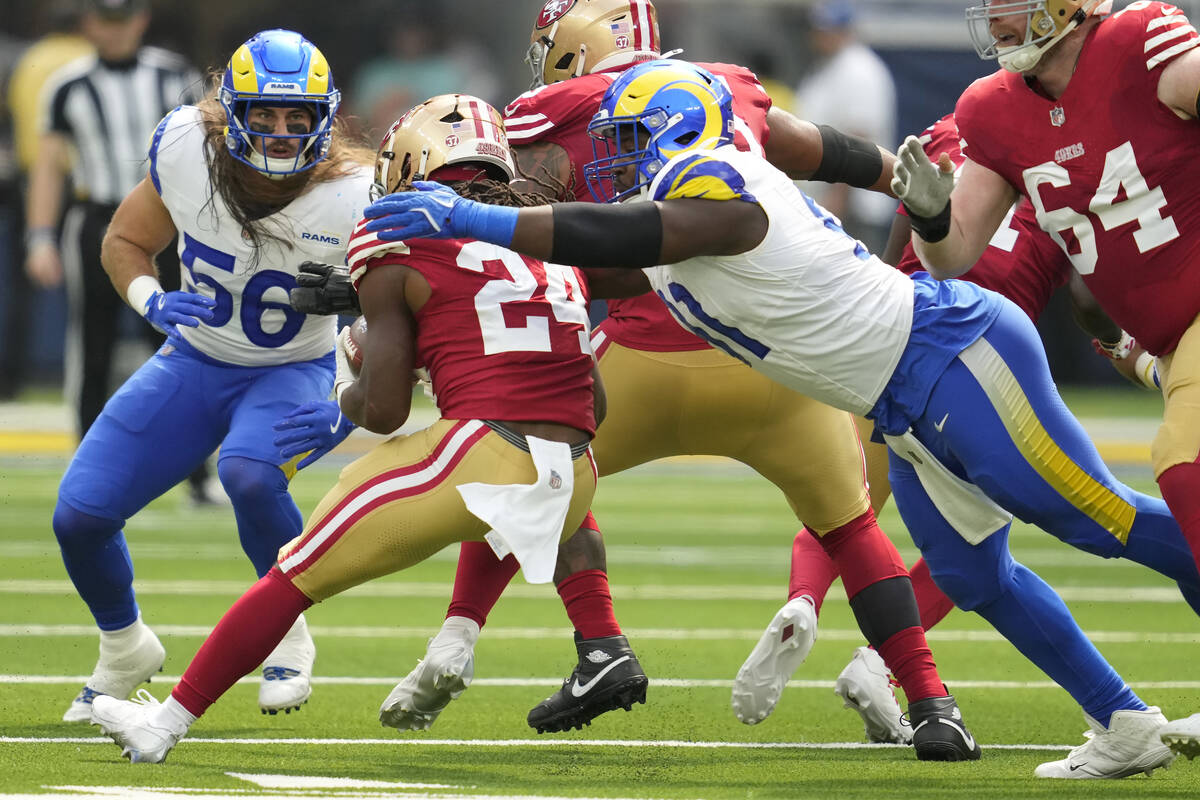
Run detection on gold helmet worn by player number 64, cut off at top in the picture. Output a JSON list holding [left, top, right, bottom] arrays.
[[967, 0, 1112, 72]]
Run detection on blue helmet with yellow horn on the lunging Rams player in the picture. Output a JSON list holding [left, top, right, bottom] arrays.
[[583, 59, 733, 203]]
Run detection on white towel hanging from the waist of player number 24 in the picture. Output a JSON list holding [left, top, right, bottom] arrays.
[[458, 437, 575, 583]]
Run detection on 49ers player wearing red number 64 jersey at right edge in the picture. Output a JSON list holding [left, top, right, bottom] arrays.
[[898, 0, 1200, 774]]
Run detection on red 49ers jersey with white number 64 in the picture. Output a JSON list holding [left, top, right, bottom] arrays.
[[955, 1, 1200, 355]]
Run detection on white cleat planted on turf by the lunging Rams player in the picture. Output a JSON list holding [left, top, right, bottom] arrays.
[[1033, 706, 1175, 778]]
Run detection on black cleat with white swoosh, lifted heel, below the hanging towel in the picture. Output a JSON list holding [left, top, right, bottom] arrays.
[[528, 631, 649, 733]]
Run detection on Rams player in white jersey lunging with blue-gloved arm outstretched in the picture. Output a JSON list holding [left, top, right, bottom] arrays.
[[366, 61, 1200, 777]]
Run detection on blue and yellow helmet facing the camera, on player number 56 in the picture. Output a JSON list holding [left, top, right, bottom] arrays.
[[217, 29, 342, 178]]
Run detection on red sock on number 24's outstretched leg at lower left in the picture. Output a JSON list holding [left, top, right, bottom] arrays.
[[170, 566, 312, 716]]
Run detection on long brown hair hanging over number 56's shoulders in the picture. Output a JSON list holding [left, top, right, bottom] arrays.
[[198, 89, 374, 258]]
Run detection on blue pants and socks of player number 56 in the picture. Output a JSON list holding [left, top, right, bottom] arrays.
[[53, 348, 332, 630]]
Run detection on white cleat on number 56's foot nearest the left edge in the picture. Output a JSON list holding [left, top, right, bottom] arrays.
[[62, 616, 167, 722]]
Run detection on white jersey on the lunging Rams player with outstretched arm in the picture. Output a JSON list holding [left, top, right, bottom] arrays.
[[646, 146, 913, 415]]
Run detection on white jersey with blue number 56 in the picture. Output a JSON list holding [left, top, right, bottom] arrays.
[[150, 106, 372, 367]]
